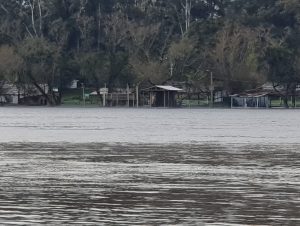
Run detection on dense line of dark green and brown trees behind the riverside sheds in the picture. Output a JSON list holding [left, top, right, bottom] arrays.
[[0, 0, 300, 107]]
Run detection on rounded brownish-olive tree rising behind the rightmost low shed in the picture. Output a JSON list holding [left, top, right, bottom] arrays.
[[211, 23, 265, 94]]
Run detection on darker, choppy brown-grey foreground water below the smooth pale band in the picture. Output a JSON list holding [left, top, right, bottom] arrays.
[[0, 143, 300, 225]]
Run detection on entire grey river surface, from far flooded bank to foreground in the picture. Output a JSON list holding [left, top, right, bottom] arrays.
[[0, 107, 300, 226]]
